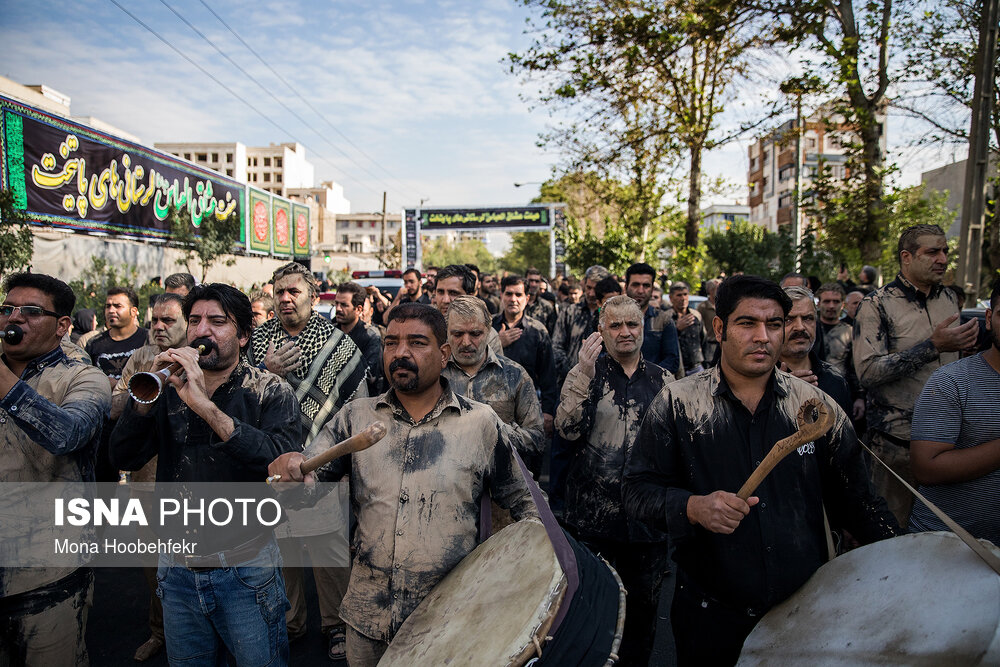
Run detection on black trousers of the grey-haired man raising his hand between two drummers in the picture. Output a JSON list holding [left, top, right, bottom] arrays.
[[581, 537, 668, 667]]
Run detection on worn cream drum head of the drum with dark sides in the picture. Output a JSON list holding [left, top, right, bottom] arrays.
[[378, 521, 566, 667]]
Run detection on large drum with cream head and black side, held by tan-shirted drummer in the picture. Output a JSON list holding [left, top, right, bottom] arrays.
[[379, 521, 625, 667]]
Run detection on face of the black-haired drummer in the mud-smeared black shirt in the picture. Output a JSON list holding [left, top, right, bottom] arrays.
[[712, 299, 785, 378]]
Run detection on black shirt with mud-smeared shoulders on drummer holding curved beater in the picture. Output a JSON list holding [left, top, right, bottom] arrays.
[[625, 367, 900, 614]]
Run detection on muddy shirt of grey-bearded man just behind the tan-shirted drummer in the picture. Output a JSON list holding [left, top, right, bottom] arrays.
[[441, 350, 545, 456]]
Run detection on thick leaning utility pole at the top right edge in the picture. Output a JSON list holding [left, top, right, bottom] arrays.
[[958, 0, 1000, 299]]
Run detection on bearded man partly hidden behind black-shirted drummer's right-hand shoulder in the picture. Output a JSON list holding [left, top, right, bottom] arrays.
[[778, 287, 851, 414]]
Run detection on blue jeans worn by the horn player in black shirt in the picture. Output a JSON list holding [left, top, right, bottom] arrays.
[[156, 539, 288, 667]]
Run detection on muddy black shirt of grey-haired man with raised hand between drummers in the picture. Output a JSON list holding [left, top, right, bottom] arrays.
[[555, 354, 673, 542]]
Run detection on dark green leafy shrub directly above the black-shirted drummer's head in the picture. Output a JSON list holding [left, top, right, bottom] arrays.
[[704, 219, 787, 279]]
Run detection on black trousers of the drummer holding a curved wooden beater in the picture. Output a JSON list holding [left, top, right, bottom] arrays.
[[670, 571, 763, 667]]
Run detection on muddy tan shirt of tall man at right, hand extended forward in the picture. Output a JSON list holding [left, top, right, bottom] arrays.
[[854, 275, 959, 446]]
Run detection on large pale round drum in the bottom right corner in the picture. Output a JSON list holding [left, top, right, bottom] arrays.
[[738, 533, 1000, 667]]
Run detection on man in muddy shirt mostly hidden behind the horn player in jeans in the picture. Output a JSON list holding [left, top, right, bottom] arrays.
[[111, 292, 187, 662]]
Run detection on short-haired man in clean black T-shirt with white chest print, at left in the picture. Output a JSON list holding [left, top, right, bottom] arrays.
[[86, 287, 149, 388]]
